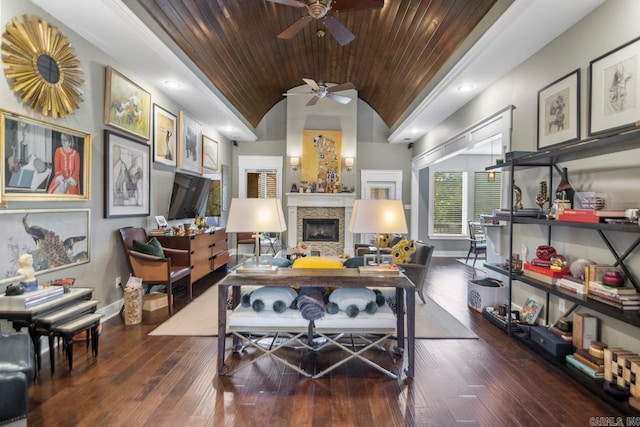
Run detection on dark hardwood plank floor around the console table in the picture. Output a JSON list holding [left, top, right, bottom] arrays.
[[28, 258, 622, 427]]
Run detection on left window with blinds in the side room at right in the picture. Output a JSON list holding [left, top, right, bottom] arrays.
[[433, 171, 467, 235]]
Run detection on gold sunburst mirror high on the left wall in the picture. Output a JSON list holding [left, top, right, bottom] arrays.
[[2, 15, 84, 118]]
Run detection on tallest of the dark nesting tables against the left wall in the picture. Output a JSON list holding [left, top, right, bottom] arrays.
[[0, 287, 93, 370]]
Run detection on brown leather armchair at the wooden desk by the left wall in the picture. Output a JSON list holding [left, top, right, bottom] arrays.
[[120, 227, 193, 314]]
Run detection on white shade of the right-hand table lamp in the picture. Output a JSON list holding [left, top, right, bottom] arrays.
[[349, 200, 408, 234]]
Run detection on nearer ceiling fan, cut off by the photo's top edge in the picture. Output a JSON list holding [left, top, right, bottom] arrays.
[[268, 0, 384, 46]]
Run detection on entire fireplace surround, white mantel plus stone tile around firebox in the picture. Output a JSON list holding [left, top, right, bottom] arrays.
[[286, 193, 356, 256]]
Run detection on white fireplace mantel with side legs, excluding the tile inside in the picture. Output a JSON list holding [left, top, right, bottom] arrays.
[[286, 193, 356, 255]]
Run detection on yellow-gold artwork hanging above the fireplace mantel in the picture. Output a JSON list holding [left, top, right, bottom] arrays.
[[300, 129, 342, 186]]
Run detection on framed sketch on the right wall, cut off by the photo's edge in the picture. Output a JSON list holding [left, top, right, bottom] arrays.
[[589, 37, 640, 136]]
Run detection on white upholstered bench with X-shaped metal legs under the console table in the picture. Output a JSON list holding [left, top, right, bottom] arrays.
[[227, 304, 397, 378]]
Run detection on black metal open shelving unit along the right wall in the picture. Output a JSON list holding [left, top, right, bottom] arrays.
[[485, 127, 640, 415]]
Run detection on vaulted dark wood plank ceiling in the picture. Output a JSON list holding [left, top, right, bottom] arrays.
[[139, 0, 496, 127]]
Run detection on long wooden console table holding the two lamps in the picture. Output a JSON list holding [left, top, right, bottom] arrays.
[[217, 268, 416, 378]]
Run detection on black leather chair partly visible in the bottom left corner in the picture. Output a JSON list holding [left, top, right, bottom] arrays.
[[0, 332, 36, 426]]
